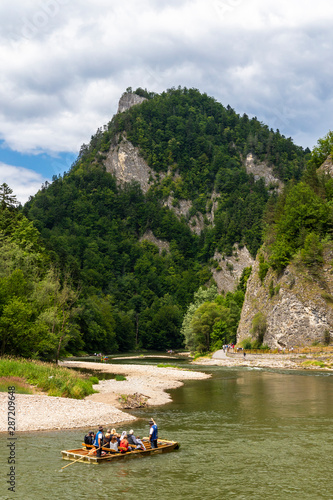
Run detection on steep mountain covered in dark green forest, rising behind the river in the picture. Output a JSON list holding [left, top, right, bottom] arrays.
[[1, 88, 308, 356]]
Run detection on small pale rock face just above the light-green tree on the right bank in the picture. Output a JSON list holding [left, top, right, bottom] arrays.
[[211, 247, 255, 293]]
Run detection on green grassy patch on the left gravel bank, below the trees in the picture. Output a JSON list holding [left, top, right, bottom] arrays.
[[0, 358, 96, 399]]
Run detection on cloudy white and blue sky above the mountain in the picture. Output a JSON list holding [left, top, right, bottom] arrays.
[[0, 0, 333, 203]]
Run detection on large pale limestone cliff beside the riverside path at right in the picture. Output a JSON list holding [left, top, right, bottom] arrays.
[[237, 245, 333, 348]]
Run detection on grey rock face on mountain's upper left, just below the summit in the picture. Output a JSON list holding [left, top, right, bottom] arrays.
[[104, 133, 156, 193]]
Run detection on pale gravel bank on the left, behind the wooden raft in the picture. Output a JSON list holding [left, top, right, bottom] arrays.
[[0, 361, 210, 433]]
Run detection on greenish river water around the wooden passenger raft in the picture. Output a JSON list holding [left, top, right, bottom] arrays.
[[0, 367, 333, 500]]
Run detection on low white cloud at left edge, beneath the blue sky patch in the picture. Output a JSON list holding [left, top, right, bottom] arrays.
[[0, 162, 49, 205]]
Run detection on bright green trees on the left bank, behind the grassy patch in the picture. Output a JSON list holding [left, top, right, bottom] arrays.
[[0, 208, 82, 360]]
